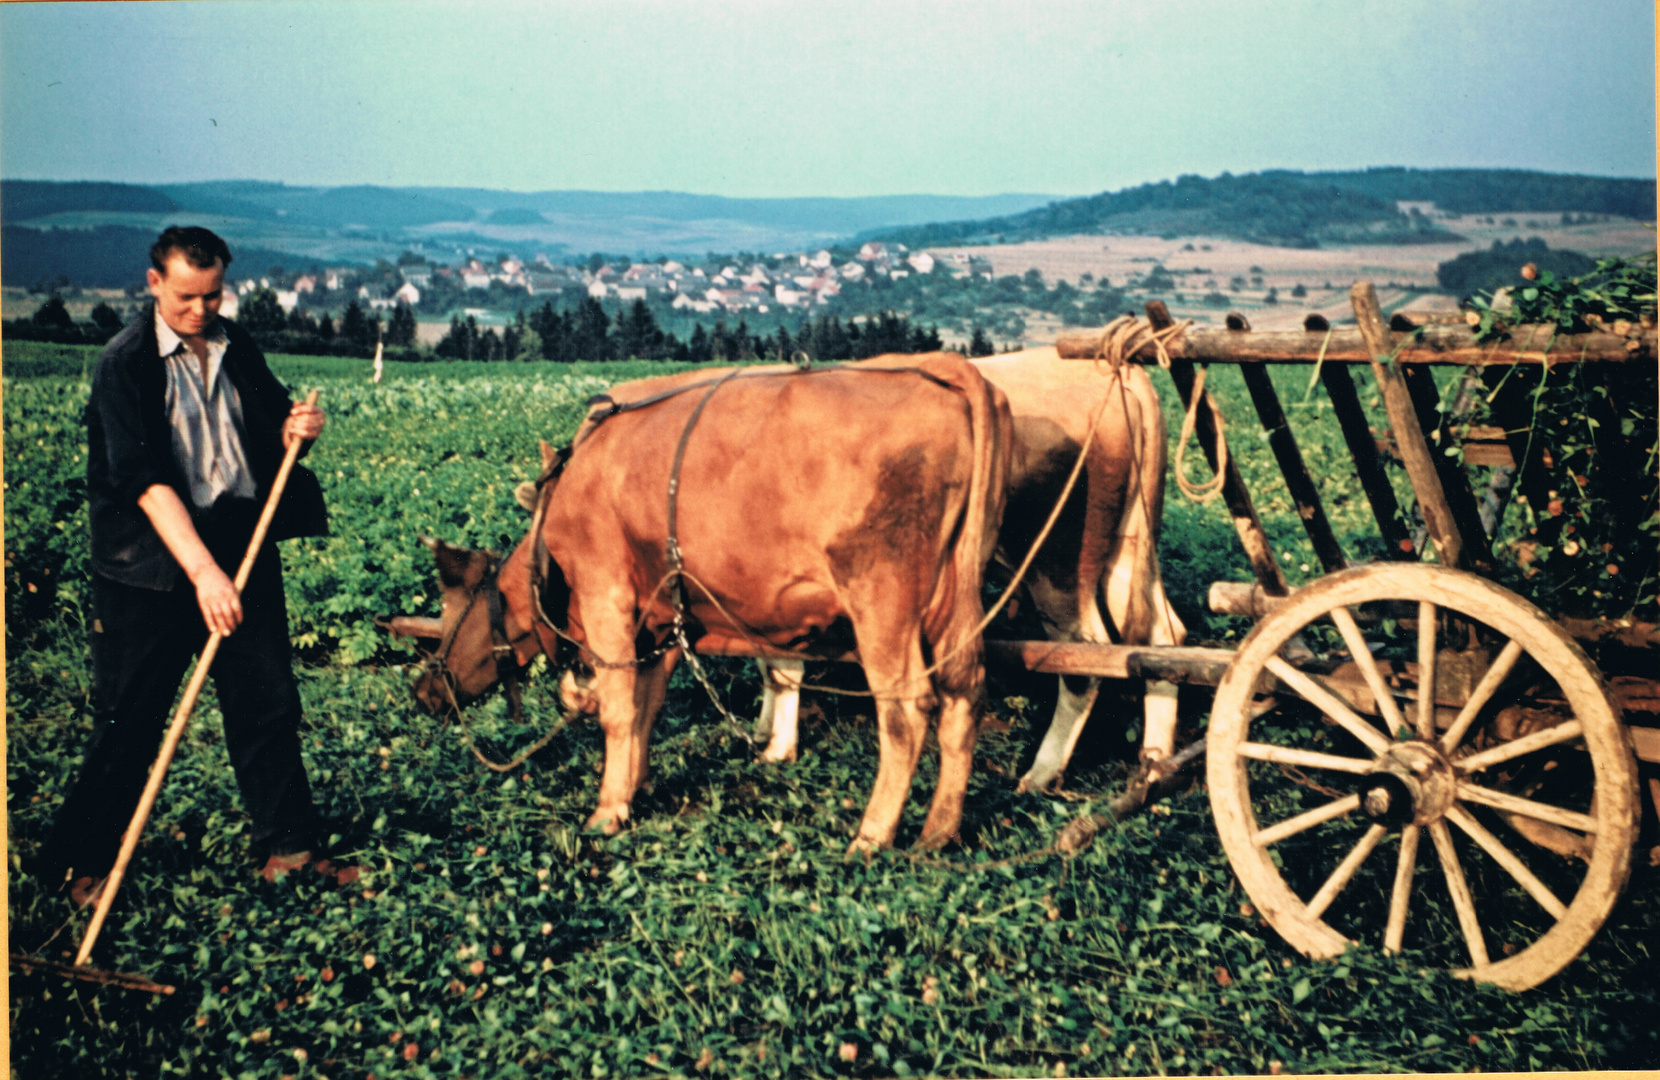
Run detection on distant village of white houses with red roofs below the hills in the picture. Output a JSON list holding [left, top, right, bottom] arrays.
[[226, 242, 991, 319]]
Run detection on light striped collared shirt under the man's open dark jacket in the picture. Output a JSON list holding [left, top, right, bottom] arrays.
[[156, 312, 256, 509]]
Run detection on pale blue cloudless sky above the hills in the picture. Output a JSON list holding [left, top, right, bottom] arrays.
[[0, 0, 1655, 196]]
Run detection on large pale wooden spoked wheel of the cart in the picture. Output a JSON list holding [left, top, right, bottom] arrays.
[[1207, 564, 1638, 989]]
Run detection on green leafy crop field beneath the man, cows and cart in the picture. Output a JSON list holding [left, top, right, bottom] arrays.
[[3, 345, 1660, 1080]]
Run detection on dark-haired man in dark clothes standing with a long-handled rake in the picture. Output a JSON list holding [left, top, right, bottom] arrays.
[[43, 226, 329, 906]]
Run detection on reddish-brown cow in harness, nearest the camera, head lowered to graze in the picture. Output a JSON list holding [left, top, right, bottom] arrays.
[[417, 353, 1011, 848]]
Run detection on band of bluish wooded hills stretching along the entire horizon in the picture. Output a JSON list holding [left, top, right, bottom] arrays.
[[0, 168, 1655, 285]]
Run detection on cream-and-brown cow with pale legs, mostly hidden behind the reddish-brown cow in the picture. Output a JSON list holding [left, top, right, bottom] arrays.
[[755, 347, 1187, 791]]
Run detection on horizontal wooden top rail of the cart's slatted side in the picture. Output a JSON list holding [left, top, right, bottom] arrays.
[[1056, 324, 1660, 365]]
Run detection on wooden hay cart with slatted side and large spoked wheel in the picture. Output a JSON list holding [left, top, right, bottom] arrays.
[[988, 282, 1660, 989]]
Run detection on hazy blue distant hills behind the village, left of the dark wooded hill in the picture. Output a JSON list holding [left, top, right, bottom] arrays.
[[0, 181, 1052, 285]]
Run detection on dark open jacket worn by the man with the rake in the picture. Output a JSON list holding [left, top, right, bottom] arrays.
[[86, 304, 329, 589]]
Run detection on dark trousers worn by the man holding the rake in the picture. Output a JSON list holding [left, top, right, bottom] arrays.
[[43, 528, 317, 878]]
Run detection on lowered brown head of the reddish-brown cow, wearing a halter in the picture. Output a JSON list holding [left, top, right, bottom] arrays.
[[415, 536, 518, 715]]
